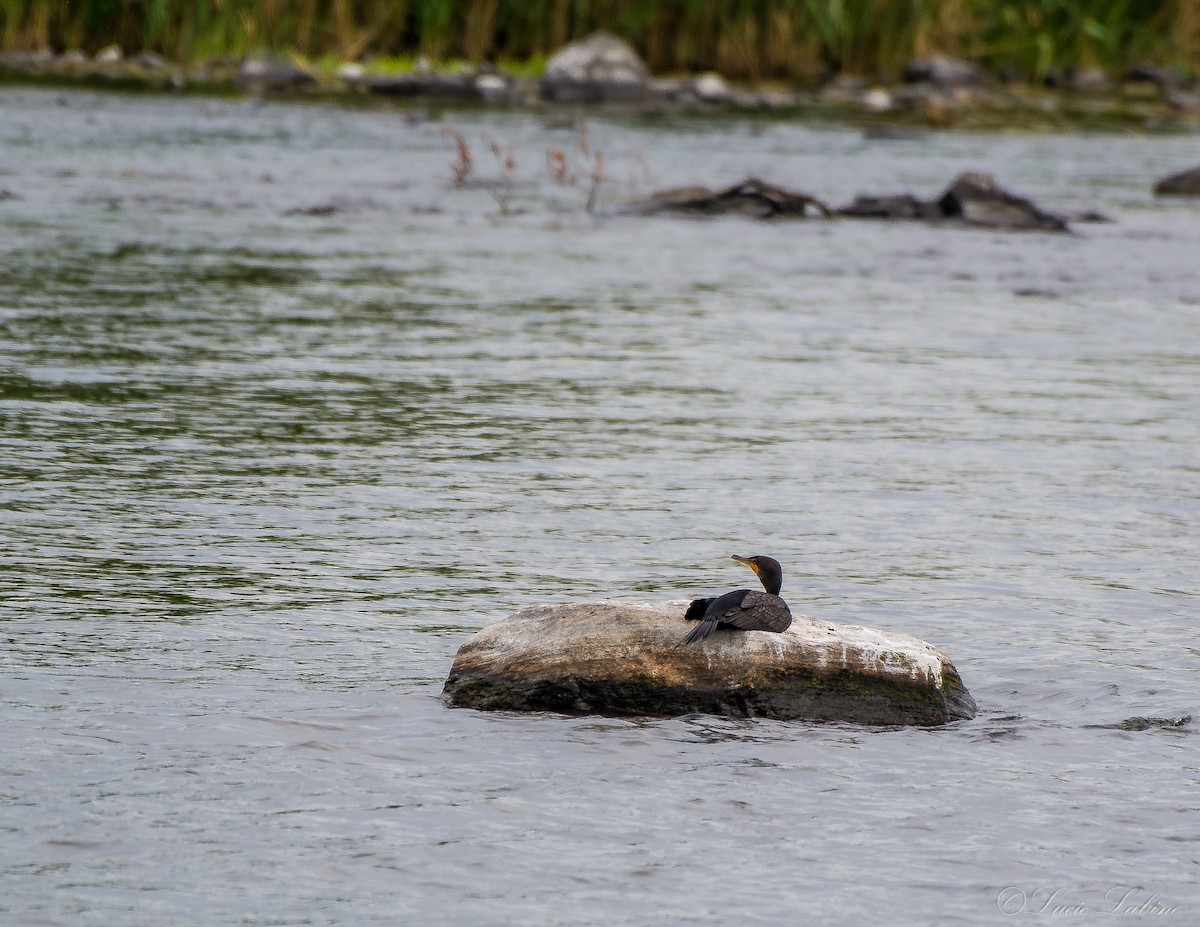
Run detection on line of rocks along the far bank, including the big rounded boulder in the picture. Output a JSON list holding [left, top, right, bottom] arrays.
[[9, 32, 1200, 125]]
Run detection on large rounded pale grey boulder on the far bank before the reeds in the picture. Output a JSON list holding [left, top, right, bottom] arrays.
[[541, 32, 650, 103]]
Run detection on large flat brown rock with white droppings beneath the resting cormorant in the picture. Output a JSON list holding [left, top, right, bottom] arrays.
[[444, 602, 976, 726]]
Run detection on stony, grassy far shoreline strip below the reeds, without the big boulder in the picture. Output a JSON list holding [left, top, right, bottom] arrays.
[[7, 48, 1200, 133]]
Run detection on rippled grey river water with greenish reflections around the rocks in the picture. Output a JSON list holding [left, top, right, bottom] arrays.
[[0, 88, 1200, 927]]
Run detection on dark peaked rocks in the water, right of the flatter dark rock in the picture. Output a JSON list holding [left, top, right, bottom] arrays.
[[838, 171, 1068, 232]]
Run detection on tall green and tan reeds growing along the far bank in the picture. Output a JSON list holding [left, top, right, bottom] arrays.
[[0, 0, 1200, 82]]
